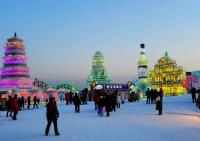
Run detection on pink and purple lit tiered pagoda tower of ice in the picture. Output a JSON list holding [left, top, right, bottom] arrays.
[[0, 33, 32, 89]]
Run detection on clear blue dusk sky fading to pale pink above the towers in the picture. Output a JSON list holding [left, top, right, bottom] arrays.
[[0, 0, 200, 86]]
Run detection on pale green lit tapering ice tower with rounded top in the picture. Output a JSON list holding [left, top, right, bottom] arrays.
[[87, 51, 112, 87]]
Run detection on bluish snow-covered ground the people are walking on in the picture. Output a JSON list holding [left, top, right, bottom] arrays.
[[0, 95, 200, 141]]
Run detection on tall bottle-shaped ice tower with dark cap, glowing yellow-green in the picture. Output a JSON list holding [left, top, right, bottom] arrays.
[[138, 44, 149, 84]]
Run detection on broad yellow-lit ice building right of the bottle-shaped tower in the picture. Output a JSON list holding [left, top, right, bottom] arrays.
[[150, 52, 187, 96]]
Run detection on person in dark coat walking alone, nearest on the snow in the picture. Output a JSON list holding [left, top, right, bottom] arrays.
[[45, 97, 60, 136]]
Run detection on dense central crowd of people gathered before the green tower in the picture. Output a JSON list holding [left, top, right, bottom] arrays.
[[65, 90, 126, 117]]
